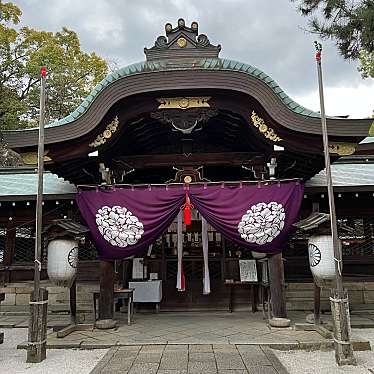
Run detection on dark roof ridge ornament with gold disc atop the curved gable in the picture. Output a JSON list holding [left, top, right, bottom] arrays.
[[144, 18, 221, 61]]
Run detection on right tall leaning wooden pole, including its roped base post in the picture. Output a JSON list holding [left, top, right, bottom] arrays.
[[314, 42, 356, 365]]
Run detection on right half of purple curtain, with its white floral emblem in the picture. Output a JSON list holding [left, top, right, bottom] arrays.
[[190, 182, 304, 253]]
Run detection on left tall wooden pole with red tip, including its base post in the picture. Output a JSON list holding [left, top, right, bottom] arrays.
[[26, 67, 48, 363]]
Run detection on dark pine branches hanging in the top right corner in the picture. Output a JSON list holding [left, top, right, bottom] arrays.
[[292, 0, 374, 59]]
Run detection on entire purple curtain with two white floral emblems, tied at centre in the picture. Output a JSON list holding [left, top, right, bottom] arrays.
[[77, 182, 303, 260]]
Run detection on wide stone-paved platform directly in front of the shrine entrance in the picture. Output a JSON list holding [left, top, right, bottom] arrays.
[[11, 312, 367, 349]]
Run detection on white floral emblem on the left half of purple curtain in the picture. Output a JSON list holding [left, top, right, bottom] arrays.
[[96, 205, 144, 247]]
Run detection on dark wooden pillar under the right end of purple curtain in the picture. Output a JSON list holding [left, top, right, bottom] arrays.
[[269, 253, 287, 318]]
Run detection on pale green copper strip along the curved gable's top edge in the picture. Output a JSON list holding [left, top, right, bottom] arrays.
[[46, 58, 320, 127]]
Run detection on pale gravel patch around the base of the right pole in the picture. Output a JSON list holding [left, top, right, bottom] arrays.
[[274, 329, 374, 374]]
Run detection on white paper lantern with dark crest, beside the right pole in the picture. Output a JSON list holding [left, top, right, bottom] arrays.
[[308, 235, 335, 286]]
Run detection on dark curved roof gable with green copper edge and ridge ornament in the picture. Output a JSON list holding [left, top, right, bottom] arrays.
[[7, 19, 374, 146]]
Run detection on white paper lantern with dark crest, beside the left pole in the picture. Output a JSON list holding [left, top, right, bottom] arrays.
[[47, 239, 78, 287]]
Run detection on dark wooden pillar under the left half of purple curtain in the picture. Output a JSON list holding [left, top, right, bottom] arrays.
[[99, 261, 114, 320]]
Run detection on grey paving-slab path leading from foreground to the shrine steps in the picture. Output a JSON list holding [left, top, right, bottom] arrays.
[[91, 344, 288, 374]]
